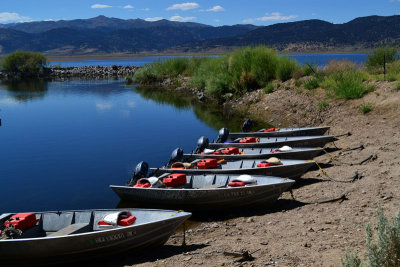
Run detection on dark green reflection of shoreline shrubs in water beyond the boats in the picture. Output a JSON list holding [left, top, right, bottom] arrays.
[[134, 87, 266, 132]]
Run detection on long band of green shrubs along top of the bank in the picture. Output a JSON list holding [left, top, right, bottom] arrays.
[[127, 46, 400, 103]]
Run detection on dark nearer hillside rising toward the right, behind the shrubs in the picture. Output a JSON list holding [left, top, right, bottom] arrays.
[[174, 16, 400, 52]]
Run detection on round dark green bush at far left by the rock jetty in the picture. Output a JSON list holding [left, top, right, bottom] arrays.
[[2, 51, 47, 74]]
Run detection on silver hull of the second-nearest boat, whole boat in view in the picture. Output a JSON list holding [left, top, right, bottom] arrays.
[[110, 175, 294, 210]]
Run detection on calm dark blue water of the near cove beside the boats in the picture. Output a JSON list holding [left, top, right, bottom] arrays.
[[0, 80, 244, 213]]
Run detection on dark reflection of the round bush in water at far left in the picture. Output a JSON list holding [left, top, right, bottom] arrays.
[[0, 80, 48, 102]]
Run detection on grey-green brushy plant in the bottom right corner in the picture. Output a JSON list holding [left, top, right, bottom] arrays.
[[342, 206, 400, 267]]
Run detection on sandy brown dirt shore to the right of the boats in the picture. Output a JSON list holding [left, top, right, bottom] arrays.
[[86, 81, 400, 266]]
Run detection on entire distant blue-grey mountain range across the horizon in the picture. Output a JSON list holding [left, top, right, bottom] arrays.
[[0, 16, 400, 55]]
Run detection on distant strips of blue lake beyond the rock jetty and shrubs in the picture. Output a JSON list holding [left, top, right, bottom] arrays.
[[51, 54, 367, 67]]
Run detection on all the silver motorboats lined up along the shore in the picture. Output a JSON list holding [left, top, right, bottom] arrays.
[[0, 120, 336, 264]]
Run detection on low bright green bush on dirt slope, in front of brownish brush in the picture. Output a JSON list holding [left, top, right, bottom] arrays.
[[321, 70, 372, 99]]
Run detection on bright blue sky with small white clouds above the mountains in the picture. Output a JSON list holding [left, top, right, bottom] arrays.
[[0, 0, 400, 26]]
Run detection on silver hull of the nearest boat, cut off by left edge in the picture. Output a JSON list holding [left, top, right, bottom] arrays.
[[0, 209, 191, 264]]
